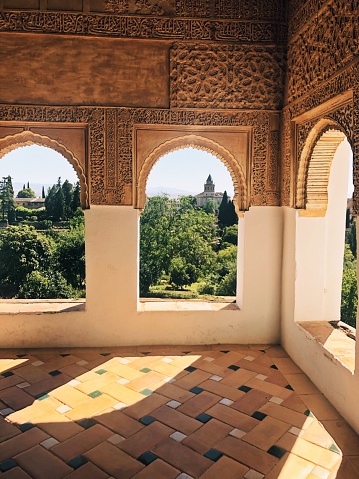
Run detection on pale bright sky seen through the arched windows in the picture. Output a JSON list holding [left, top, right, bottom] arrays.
[[0, 144, 353, 198]]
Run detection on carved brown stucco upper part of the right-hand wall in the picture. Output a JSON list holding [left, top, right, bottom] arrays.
[[281, 0, 359, 212]]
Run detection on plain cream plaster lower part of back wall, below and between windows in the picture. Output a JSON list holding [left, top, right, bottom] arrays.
[[0, 206, 283, 348]]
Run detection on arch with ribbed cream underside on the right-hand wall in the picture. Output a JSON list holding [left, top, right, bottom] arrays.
[[296, 119, 346, 216]]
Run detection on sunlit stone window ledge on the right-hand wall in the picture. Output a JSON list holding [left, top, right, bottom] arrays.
[[297, 321, 356, 373]]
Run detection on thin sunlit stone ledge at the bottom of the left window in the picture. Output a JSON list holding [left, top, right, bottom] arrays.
[[0, 299, 86, 315]]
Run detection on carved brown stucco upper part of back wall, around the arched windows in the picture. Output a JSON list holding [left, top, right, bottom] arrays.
[[0, 0, 286, 210]]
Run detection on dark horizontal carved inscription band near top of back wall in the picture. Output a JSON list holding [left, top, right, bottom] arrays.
[[0, 11, 286, 44]]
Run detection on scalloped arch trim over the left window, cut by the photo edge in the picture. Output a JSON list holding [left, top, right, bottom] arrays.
[[0, 131, 90, 209]]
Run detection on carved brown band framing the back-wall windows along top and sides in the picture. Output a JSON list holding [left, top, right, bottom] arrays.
[[0, 105, 279, 205]]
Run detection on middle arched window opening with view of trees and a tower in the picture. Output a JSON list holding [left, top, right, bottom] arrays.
[[139, 147, 238, 302]]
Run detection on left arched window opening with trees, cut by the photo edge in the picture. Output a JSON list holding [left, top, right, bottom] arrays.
[[0, 145, 85, 299]]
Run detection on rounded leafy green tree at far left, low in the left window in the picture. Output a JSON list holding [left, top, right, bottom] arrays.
[[0, 225, 54, 289]]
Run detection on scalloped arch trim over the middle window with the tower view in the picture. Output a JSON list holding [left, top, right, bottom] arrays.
[[135, 135, 249, 215]]
